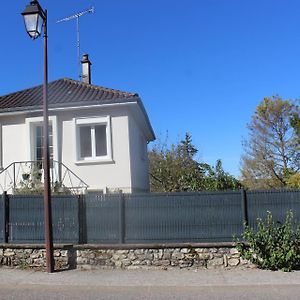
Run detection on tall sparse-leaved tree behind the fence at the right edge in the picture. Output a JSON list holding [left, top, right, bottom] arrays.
[[241, 96, 300, 189]]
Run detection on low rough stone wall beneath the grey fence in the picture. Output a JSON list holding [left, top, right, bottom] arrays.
[[0, 244, 253, 269]]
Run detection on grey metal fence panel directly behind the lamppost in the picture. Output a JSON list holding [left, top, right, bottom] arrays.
[[7, 195, 79, 243]]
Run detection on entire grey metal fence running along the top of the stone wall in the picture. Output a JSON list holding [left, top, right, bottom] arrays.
[[0, 190, 300, 243]]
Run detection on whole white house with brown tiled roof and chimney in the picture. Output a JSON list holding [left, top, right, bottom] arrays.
[[0, 55, 155, 193]]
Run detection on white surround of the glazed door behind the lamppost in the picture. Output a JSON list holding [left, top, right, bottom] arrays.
[[25, 116, 58, 161]]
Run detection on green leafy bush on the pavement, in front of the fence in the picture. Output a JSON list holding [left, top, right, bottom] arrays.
[[237, 211, 300, 272]]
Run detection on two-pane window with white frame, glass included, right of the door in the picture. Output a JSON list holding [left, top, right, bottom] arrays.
[[75, 117, 112, 162]]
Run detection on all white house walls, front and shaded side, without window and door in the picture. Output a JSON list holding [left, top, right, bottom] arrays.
[[0, 106, 149, 192]]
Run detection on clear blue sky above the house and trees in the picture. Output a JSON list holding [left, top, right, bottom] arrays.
[[0, 0, 300, 175]]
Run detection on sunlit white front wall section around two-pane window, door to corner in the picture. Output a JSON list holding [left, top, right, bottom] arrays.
[[58, 108, 131, 192]]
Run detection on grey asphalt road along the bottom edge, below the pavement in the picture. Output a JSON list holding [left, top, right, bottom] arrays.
[[0, 285, 300, 300]]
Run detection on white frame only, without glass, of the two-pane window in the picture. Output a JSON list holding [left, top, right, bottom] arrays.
[[74, 116, 113, 164]]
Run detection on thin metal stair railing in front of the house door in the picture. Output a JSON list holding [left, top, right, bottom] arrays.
[[0, 160, 88, 194]]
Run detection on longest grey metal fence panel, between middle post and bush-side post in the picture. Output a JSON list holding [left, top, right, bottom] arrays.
[[125, 192, 243, 243]]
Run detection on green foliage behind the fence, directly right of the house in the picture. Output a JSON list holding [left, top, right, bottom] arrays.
[[149, 133, 240, 192]]
